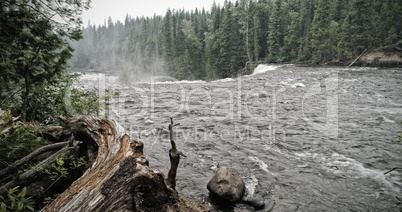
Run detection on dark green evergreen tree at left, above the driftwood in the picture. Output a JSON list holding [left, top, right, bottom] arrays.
[[0, 0, 89, 122]]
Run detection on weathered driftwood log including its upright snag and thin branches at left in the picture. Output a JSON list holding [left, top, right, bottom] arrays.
[[0, 116, 209, 211]]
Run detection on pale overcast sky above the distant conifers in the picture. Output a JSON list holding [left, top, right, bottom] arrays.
[[83, 0, 229, 26]]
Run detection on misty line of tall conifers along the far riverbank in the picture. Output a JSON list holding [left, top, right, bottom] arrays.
[[71, 0, 402, 80]]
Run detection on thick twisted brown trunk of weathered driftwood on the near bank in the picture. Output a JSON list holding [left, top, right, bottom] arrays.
[[43, 117, 209, 211]]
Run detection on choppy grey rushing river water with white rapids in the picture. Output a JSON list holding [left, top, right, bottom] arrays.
[[77, 65, 402, 211]]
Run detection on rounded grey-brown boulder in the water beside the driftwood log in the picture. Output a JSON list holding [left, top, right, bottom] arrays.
[[207, 167, 245, 202]]
